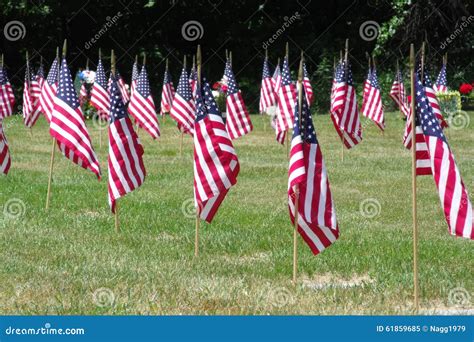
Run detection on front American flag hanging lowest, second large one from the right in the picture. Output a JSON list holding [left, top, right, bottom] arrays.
[[288, 87, 339, 254]]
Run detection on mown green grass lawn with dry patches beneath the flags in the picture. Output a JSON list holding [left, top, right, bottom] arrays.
[[0, 112, 474, 315]]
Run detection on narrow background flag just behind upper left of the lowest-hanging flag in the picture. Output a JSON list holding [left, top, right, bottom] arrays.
[[276, 57, 296, 139]]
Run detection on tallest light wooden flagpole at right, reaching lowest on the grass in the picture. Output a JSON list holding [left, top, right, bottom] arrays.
[[410, 44, 419, 312]]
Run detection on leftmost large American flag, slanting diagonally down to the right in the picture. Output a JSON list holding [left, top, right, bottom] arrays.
[[49, 58, 100, 179]]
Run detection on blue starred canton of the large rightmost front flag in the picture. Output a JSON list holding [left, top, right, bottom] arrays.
[[415, 74, 446, 142]]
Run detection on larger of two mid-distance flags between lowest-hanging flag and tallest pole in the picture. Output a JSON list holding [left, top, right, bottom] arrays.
[[331, 62, 362, 149]]
